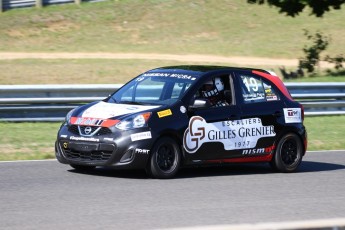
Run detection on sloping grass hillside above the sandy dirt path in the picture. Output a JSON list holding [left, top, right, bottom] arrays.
[[0, 0, 345, 58]]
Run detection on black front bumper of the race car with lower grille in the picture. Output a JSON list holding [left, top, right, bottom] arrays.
[[55, 126, 153, 169]]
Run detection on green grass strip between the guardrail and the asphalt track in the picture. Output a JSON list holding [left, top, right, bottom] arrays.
[[0, 116, 345, 161]]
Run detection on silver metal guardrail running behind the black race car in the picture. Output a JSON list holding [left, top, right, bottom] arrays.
[[0, 82, 345, 121]]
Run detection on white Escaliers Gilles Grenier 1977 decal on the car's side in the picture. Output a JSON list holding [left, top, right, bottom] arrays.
[[183, 116, 276, 153]]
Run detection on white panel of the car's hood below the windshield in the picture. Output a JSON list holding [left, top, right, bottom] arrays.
[[79, 101, 160, 119]]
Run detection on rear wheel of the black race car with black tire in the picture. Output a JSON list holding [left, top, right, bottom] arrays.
[[270, 133, 303, 173]]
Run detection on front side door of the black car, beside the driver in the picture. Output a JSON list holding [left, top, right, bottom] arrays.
[[184, 74, 240, 161]]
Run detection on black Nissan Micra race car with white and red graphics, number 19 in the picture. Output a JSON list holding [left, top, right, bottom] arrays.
[[55, 65, 307, 178]]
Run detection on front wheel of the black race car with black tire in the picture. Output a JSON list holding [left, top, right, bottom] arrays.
[[147, 137, 181, 179]]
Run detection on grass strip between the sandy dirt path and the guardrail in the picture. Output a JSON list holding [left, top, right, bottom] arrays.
[[0, 59, 345, 85]]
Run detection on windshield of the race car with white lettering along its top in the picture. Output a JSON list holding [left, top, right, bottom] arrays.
[[108, 73, 195, 105]]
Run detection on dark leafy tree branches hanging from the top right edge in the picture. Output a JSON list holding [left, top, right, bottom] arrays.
[[247, 0, 345, 17]]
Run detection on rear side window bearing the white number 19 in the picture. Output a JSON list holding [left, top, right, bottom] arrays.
[[240, 75, 279, 103]]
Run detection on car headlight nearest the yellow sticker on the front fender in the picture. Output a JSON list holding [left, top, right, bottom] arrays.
[[115, 113, 151, 130]]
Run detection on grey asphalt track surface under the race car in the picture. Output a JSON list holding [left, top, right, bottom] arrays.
[[0, 151, 345, 230]]
